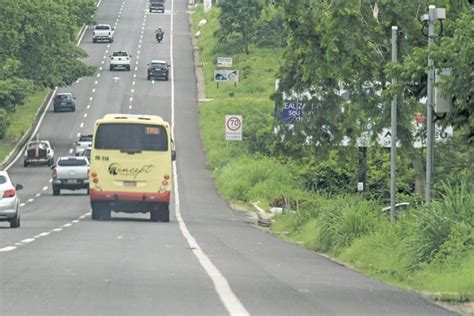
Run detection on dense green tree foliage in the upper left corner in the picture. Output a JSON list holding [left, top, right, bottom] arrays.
[[0, 0, 95, 136]]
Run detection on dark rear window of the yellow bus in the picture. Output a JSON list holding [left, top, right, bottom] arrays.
[[94, 123, 168, 152]]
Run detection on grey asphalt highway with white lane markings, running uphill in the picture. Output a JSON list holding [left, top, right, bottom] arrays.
[[0, 0, 449, 315]]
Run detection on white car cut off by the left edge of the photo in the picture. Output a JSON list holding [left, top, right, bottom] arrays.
[[0, 171, 23, 228]]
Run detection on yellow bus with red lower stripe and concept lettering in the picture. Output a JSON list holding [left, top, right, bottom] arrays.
[[89, 114, 176, 222]]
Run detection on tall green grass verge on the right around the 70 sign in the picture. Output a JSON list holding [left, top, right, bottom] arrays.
[[192, 4, 474, 301]]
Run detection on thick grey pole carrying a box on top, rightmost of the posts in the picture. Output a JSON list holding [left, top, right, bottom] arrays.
[[425, 5, 436, 205]]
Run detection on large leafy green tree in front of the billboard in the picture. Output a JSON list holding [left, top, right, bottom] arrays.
[[274, 0, 473, 198]]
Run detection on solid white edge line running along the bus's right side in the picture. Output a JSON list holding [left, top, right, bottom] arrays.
[[170, 0, 249, 315]]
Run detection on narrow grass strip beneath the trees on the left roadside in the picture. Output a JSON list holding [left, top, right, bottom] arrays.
[[0, 89, 49, 162]]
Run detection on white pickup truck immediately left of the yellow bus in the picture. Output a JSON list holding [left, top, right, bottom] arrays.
[[51, 156, 89, 195]]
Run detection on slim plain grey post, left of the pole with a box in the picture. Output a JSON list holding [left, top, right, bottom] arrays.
[[390, 26, 398, 222]]
